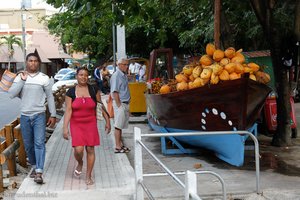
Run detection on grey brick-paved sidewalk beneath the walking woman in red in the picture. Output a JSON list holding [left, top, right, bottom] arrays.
[[15, 119, 134, 200]]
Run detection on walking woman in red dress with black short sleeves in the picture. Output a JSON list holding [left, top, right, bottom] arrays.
[[63, 68, 111, 185]]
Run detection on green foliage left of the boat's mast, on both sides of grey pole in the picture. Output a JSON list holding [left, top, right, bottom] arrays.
[[47, 0, 213, 58]]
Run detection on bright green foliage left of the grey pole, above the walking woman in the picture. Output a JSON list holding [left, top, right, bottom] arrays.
[[47, 0, 113, 60]]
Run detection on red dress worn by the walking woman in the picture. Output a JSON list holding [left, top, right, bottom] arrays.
[[70, 97, 100, 147]]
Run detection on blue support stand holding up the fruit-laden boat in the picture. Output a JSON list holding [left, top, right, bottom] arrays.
[[160, 123, 257, 155]]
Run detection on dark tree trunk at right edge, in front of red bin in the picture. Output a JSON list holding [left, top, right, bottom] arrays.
[[250, 0, 300, 146]]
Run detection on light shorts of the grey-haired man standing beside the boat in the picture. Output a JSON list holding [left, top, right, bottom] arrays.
[[113, 101, 129, 129]]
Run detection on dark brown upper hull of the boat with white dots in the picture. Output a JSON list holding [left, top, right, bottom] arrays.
[[146, 78, 271, 131]]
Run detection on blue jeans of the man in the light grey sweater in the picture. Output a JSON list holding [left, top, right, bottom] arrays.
[[20, 113, 46, 173]]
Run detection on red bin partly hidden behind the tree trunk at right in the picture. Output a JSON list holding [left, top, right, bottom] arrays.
[[264, 96, 297, 137]]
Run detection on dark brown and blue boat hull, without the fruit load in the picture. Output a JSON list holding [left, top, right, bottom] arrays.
[[145, 48, 271, 166]]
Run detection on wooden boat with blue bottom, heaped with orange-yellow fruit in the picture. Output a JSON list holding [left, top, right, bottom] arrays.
[[145, 46, 271, 166]]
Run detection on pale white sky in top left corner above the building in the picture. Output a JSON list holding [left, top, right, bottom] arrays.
[[0, 0, 55, 10]]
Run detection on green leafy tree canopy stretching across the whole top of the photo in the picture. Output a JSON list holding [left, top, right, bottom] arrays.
[[47, 0, 294, 59]]
